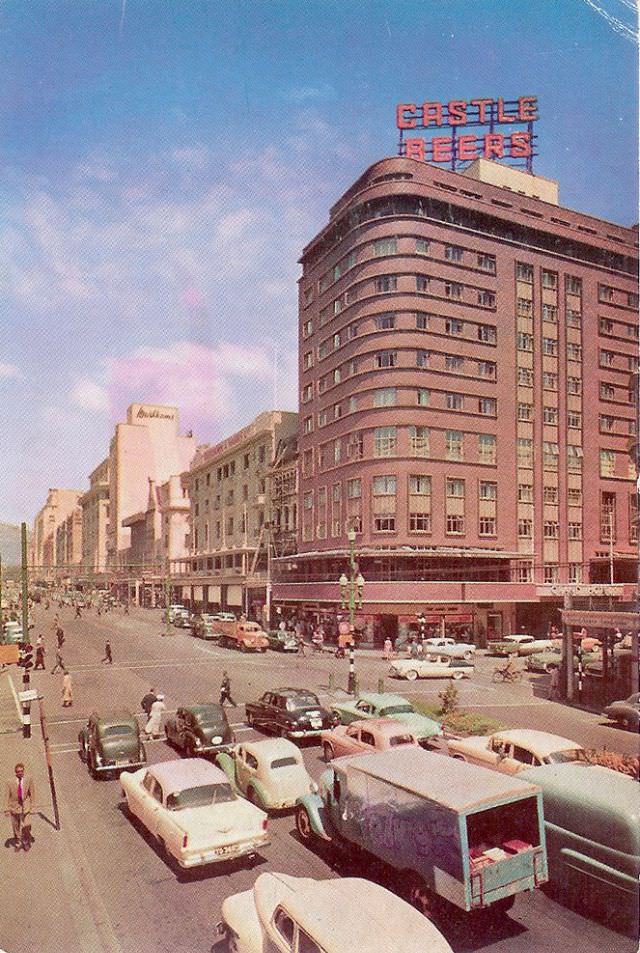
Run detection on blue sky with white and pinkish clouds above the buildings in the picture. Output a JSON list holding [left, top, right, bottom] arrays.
[[0, 0, 637, 522]]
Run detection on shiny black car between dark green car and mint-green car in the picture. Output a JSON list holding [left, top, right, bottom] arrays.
[[245, 688, 338, 738]]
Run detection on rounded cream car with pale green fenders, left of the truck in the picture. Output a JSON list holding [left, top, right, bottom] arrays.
[[216, 738, 316, 811]]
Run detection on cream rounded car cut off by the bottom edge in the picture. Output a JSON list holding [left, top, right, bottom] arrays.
[[212, 871, 451, 953]]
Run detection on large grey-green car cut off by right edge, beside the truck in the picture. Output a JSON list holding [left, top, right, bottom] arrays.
[[518, 764, 640, 928]]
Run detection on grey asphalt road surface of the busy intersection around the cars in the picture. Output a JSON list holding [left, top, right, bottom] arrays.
[[0, 608, 637, 953]]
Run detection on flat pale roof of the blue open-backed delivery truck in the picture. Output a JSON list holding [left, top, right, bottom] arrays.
[[332, 745, 538, 814]]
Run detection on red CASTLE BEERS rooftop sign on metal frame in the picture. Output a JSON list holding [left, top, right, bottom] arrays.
[[396, 96, 538, 172]]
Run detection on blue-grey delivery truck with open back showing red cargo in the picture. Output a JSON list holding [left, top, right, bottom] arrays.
[[296, 747, 547, 913]]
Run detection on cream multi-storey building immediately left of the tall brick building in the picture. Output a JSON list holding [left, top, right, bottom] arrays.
[[172, 411, 298, 616]]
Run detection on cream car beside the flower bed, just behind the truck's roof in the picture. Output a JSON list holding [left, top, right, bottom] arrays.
[[447, 728, 588, 774]]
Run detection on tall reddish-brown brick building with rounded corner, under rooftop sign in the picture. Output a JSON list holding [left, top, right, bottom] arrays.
[[274, 157, 638, 637]]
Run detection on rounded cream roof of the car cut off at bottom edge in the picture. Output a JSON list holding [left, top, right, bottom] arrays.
[[254, 872, 451, 953]]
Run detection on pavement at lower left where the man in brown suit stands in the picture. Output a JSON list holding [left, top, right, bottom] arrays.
[[0, 692, 121, 953]]
